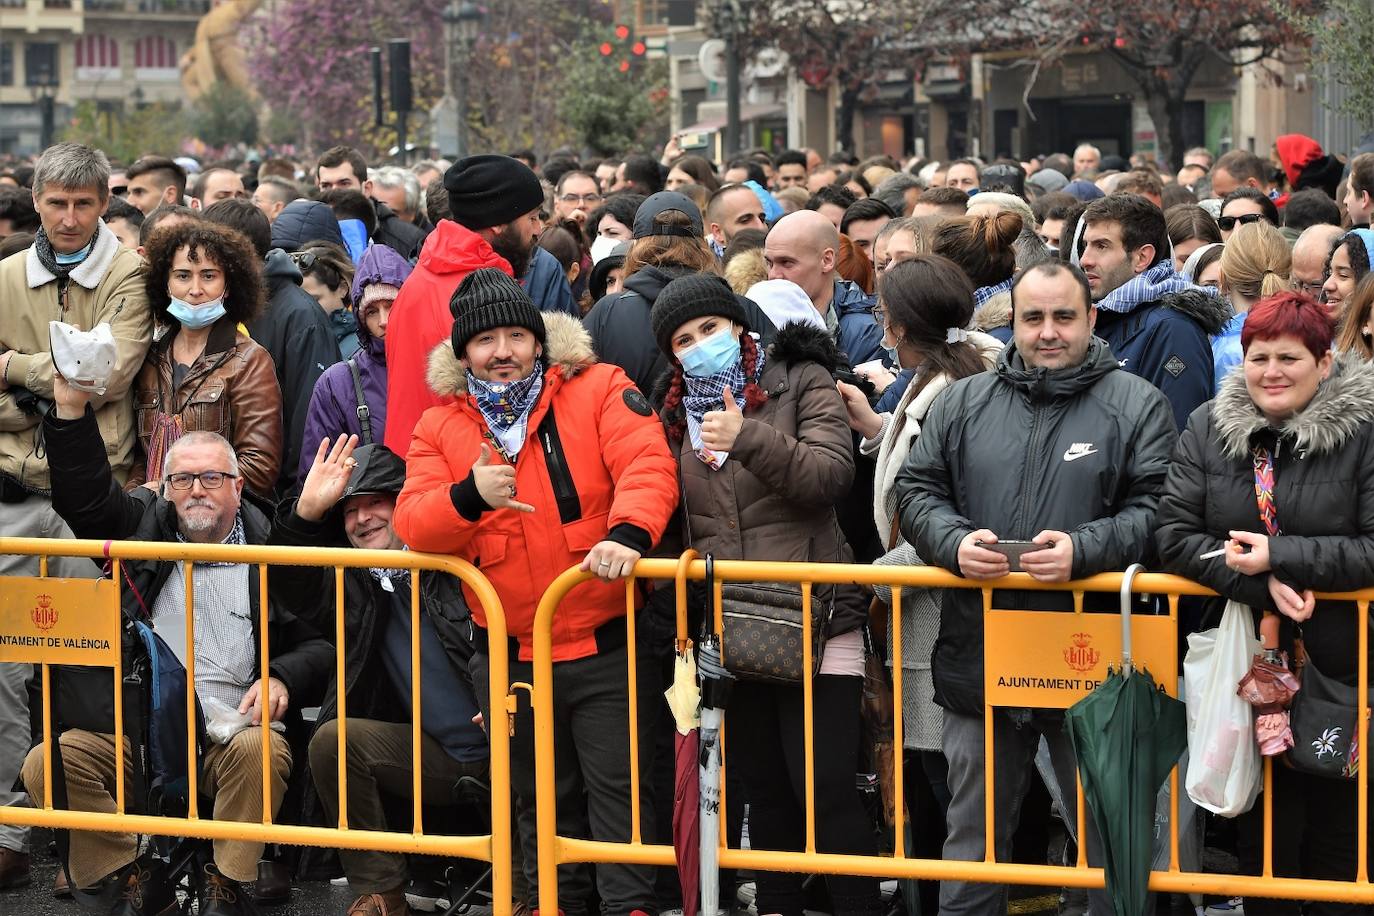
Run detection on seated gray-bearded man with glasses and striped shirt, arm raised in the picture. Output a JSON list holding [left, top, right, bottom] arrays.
[[23, 376, 334, 916]]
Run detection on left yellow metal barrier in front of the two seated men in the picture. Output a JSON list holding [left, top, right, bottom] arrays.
[[0, 537, 514, 916]]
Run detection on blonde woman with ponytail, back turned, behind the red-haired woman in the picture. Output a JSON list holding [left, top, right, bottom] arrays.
[[1212, 220, 1293, 390]]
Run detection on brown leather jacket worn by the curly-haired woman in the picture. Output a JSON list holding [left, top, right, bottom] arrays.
[[126, 319, 282, 497]]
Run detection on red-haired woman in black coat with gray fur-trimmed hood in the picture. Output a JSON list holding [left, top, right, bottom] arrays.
[[1158, 293, 1374, 913]]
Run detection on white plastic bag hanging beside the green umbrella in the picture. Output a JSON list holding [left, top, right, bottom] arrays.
[[1183, 602, 1264, 817]]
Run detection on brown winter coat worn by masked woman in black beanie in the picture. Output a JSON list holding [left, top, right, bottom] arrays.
[[664, 324, 867, 636]]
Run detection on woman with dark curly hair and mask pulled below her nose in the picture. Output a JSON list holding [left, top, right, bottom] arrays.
[[129, 221, 282, 496]]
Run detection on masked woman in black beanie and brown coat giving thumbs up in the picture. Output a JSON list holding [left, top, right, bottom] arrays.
[[651, 273, 881, 916]]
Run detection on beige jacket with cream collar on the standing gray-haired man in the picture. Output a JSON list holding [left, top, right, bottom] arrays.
[[0, 222, 153, 493]]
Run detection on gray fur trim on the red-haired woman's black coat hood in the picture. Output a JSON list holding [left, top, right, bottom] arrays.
[[1212, 354, 1374, 459]]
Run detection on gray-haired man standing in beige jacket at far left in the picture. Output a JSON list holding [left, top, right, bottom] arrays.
[[0, 143, 153, 889]]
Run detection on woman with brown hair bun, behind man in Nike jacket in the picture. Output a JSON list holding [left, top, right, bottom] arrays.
[[930, 213, 1021, 343]]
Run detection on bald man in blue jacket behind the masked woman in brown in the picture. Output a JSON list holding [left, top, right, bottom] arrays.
[[764, 210, 883, 365]]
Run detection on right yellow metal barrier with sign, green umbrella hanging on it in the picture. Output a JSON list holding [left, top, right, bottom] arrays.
[[533, 552, 1374, 912]]
